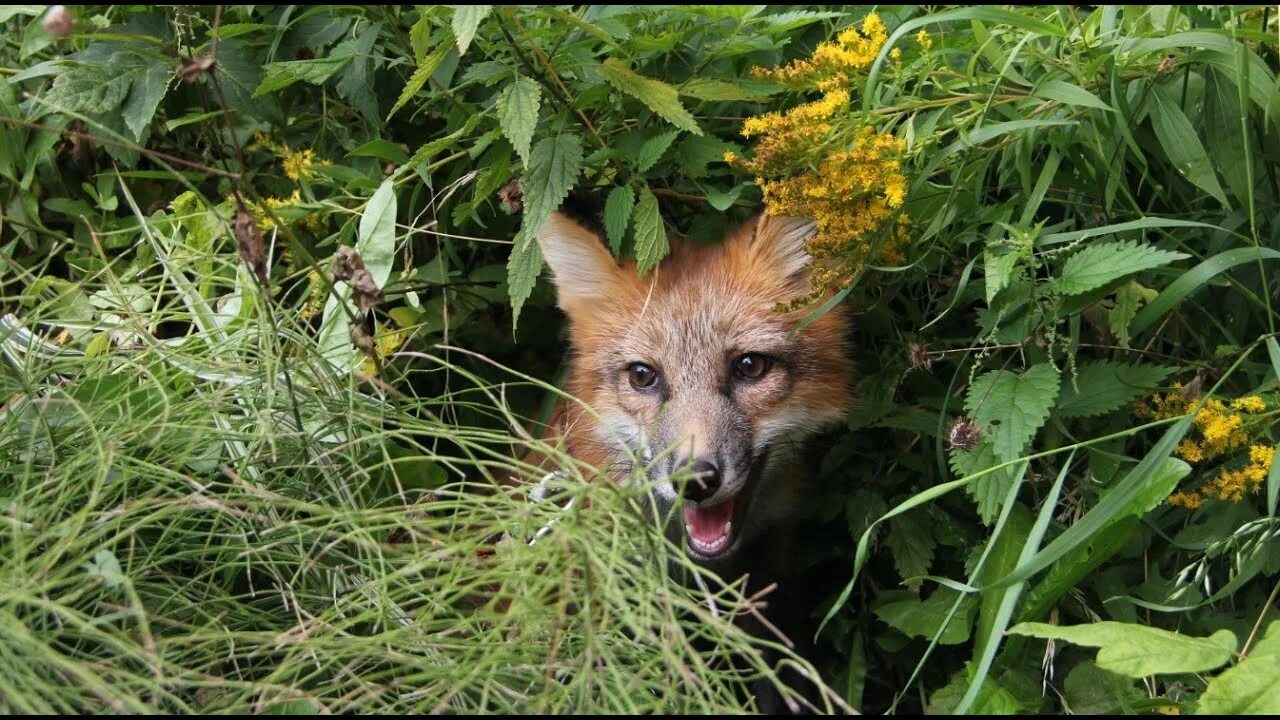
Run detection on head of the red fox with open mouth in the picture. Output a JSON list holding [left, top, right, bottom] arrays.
[[538, 207, 850, 564]]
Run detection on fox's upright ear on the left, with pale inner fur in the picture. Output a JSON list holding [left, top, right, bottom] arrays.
[[538, 213, 620, 309]]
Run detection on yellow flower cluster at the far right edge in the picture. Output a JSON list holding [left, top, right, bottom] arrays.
[[1135, 383, 1275, 510]]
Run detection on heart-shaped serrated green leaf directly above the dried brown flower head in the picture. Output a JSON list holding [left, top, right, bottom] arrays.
[[965, 363, 1059, 462]]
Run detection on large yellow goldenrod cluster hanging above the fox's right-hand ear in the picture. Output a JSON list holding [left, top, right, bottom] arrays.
[[724, 13, 909, 299]]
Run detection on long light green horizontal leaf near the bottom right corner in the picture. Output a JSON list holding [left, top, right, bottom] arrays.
[[1009, 621, 1239, 678]]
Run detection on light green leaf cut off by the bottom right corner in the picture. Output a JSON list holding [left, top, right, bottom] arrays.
[[1196, 620, 1280, 715]]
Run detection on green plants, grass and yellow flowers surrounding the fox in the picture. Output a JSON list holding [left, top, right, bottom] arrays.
[[0, 5, 1280, 712]]
